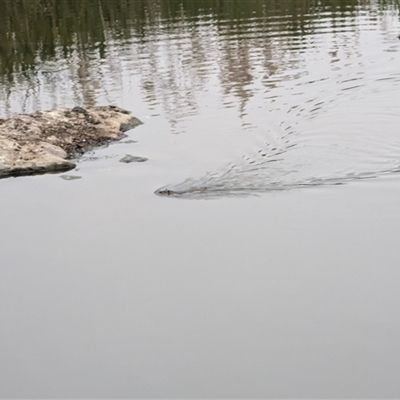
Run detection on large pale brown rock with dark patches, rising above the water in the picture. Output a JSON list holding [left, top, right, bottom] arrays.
[[0, 106, 142, 178]]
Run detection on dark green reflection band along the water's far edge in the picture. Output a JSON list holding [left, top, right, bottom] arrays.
[[0, 0, 395, 79]]
